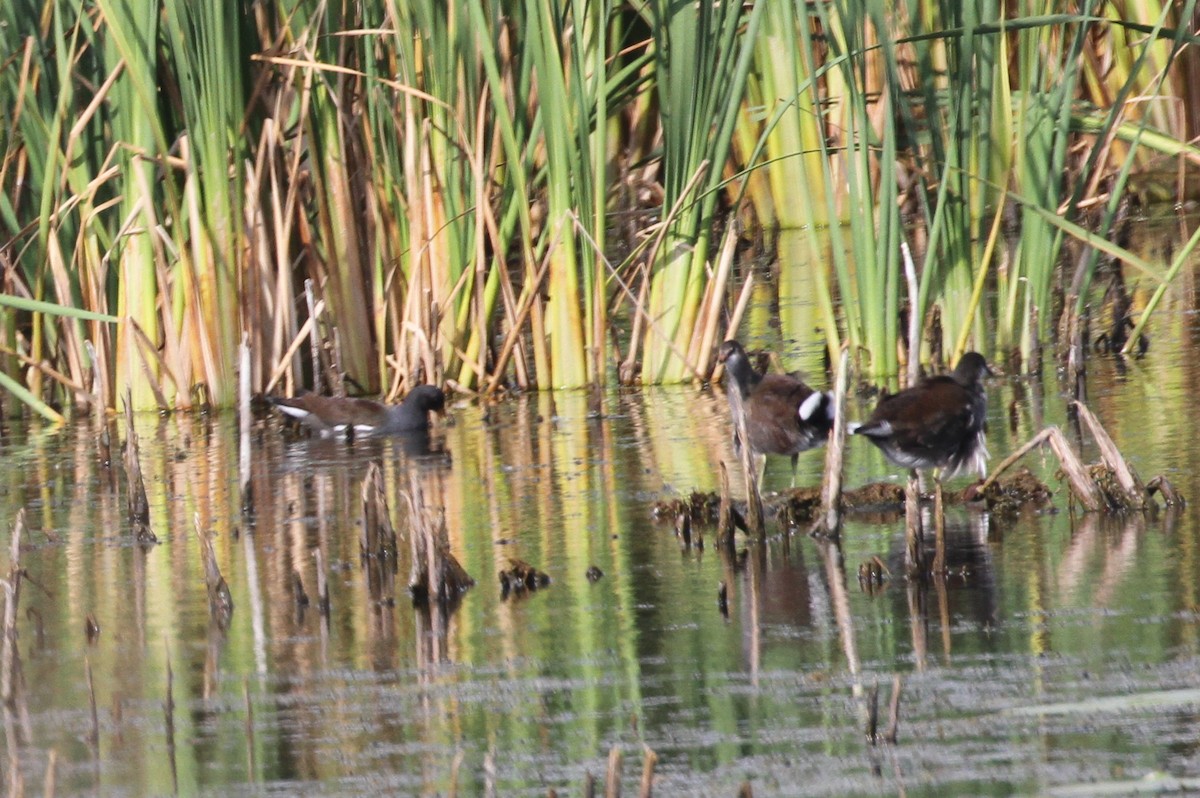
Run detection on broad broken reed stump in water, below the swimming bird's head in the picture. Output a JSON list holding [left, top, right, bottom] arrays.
[[404, 473, 475, 606]]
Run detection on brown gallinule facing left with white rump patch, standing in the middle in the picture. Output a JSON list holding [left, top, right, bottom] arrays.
[[716, 340, 833, 474]]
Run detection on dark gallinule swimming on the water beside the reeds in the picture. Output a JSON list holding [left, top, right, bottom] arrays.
[[268, 385, 445, 436]]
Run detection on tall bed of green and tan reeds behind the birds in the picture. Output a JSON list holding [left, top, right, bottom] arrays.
[[0, 0, 1200, 410]]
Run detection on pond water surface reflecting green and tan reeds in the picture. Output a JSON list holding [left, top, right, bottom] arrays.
[[0, 369, 1200, 794]]
